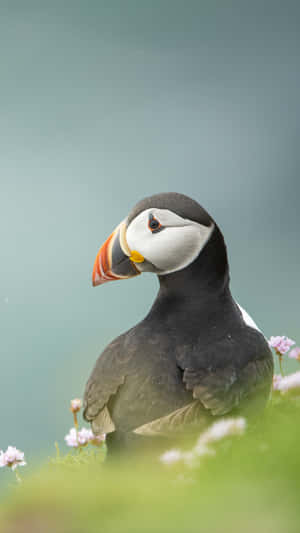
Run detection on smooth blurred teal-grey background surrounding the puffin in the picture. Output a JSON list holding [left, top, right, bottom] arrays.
[[0, 0, 300, 456]]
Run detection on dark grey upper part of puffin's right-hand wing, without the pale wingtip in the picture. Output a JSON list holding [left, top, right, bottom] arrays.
[[177, 327, 273, 416]]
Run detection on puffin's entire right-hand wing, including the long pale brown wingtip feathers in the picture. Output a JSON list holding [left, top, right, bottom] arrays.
[[134, 326, 273, 436]]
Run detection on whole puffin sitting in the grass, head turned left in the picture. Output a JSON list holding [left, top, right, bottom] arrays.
[[84, 192, 273, 453]]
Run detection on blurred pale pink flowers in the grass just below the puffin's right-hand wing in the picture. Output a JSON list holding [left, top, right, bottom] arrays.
[[160, 417, 246, 467]]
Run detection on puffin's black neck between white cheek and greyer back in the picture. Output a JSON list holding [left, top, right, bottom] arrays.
[[154, 226, 229, 306]]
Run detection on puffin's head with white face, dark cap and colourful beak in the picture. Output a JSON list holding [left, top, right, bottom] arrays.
[[93, 193, 226, 286]]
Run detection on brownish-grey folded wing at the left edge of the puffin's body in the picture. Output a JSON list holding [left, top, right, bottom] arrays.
[[83, 336, 128, 435]]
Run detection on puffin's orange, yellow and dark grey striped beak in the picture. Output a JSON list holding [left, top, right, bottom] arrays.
[[92, 221, 144, 287]]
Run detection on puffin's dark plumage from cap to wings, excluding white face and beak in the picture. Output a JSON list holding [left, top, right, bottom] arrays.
[[84, 193, 273, 450]]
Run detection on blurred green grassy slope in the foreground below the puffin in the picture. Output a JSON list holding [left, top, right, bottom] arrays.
[[0, 397, 300, 533]]
